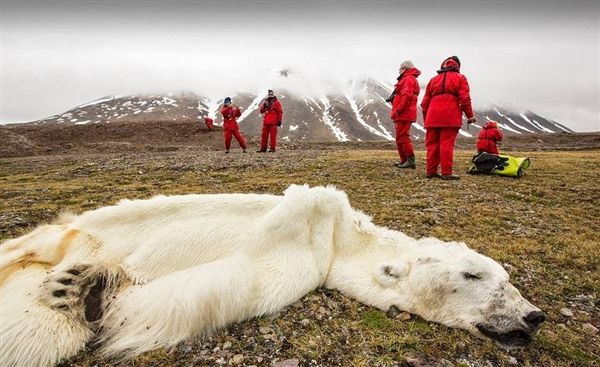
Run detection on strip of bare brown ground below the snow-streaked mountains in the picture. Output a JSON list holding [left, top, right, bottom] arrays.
[[0, 121, 600, 158]]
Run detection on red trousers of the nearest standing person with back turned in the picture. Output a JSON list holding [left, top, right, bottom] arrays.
[[425, 127, 458, 176]]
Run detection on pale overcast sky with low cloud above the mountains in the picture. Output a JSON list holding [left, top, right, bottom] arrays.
[[0, 0, 600, 131]]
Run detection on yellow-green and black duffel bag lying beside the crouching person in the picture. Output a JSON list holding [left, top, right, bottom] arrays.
[[467, 152, 531, 177]]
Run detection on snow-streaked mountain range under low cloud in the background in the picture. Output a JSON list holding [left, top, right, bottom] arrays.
[[19, 79, 573, 142]]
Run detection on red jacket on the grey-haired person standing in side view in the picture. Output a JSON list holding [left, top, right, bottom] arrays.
[[390, 68, 421, 122]]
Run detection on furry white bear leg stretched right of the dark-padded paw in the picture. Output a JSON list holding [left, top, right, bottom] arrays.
[[99, 256, 263, 357]]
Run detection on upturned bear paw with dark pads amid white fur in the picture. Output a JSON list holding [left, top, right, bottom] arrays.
[[42, 264, 116, 324]]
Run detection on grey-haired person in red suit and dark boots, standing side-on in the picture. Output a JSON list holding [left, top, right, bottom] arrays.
[[390, 60, 421, 169]]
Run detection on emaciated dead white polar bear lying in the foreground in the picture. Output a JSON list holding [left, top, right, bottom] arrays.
[[0, 185, 544, 367]]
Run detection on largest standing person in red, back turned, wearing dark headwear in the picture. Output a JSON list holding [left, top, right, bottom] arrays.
[[421, 56, 476, 180]]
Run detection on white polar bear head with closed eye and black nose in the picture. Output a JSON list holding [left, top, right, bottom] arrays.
[[375, 238, 545, 346]]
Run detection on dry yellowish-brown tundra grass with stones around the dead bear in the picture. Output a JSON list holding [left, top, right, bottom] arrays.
[[0, 150, 600, 366]]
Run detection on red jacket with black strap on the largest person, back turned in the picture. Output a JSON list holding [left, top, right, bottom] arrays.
[[421, 58, 473, 128]]
